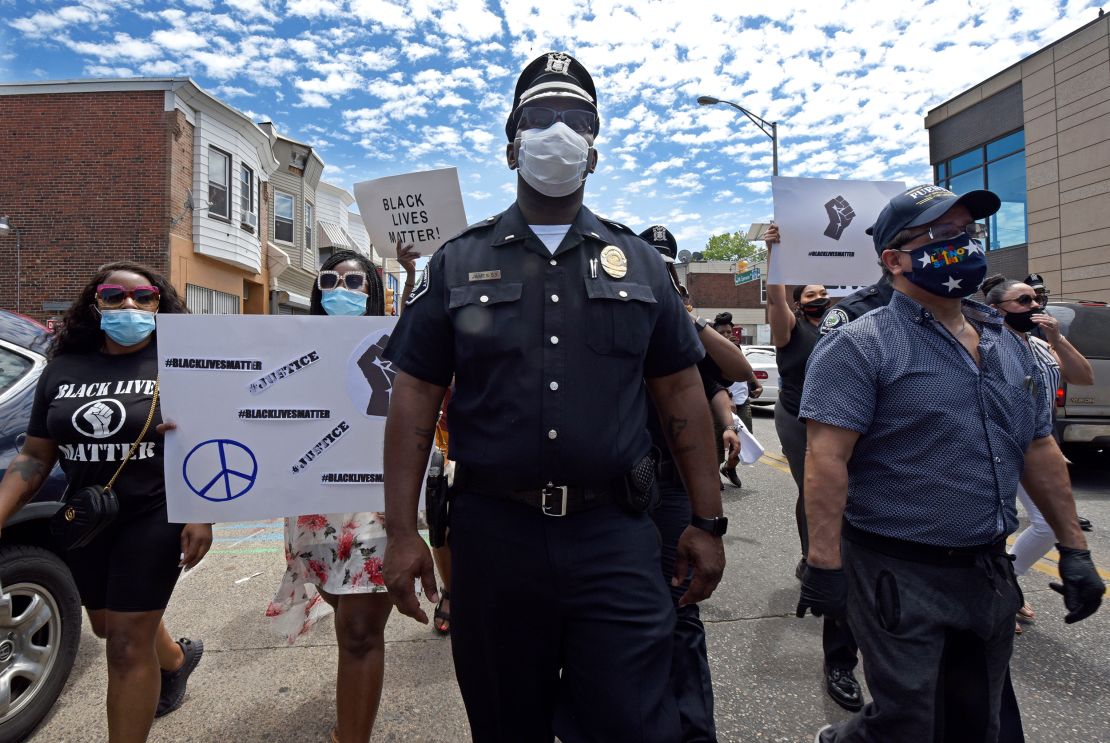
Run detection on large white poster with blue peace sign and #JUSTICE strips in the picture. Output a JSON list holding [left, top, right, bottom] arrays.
[[158, 314, 417, 523]]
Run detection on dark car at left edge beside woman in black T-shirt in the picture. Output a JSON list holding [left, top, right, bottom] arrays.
[[0, 311, 81, 741]]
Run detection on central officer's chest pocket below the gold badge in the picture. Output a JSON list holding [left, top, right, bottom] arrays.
[[584, 279, 656, 357]]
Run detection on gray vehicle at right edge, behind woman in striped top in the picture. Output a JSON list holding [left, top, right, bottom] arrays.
[[1046, 301, 1110, 464]]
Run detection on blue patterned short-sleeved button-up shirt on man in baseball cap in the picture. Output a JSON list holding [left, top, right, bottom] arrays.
[[800, 292, 1051, 548]]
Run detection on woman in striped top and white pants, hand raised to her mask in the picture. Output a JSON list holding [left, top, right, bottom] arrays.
[[979, 274, 1094, 634]]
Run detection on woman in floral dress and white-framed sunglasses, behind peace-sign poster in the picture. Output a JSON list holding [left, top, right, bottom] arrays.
[[266, 242, 417, 743]]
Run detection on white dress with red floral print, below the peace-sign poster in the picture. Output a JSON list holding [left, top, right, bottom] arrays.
[[266, 513, 385, 644]]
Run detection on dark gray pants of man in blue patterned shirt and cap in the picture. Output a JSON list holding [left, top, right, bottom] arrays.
[[821, 540, 1021, 743]]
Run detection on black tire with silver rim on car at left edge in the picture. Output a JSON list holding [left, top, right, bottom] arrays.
[[0, 544, 81, 741]]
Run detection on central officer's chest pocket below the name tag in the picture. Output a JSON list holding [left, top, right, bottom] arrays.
[[450, 282, 524, 355]]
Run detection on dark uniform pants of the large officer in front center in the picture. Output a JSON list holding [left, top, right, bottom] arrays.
[[451, 490, 680, 743]]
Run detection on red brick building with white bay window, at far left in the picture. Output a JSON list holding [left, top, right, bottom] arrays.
[[0, 78, 278, 319]]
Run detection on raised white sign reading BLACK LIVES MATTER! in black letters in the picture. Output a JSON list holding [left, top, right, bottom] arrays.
[[354, 168, 466, 258]]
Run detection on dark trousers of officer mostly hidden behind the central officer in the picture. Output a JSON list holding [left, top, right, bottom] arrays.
[[652, 475, 717, 743]]
